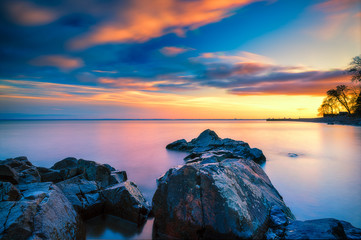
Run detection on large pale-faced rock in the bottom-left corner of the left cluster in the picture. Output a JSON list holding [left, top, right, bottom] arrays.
[[0, 183, 85, 240]]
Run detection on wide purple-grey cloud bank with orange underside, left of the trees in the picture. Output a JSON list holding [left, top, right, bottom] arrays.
[[193, 50, 349, 96]]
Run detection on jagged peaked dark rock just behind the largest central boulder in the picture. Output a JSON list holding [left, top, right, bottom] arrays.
[[166, 129, 266, 163]]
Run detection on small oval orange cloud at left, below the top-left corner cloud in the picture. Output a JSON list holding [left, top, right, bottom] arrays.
[[30, 55, 83, 70]]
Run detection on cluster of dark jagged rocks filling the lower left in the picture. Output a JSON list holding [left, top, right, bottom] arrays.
[[0, 157, 150, 239]]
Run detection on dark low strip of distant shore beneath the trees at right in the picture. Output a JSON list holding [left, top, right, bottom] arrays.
[[266, 116, 361, 127]]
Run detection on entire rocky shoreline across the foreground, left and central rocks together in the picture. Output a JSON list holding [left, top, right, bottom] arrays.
[[0, 130, 361, 239]]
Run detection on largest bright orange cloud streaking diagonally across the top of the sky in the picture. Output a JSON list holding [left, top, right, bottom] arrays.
[[70, 0, 260, 48]]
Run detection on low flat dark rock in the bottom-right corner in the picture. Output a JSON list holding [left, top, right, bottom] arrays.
[[284, 218, 361, 239]]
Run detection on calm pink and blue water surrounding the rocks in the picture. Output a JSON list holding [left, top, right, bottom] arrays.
[[0, 121, 361, 239]]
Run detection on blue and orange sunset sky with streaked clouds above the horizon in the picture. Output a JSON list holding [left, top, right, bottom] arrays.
[[0, 0, 361, 119]]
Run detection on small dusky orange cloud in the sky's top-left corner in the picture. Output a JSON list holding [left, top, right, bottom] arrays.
[[8, 2, 58, 26]]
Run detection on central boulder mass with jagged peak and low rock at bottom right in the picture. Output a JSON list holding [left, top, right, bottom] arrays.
[[153, 130, 361, 239]]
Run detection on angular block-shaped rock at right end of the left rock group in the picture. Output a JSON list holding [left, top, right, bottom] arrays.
[[102, 181, 150, 225]]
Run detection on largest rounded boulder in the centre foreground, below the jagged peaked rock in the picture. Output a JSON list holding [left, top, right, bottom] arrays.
[[153, 158, 294, 239]]
